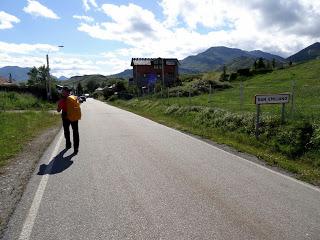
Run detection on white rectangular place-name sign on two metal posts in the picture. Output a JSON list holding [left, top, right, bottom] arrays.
[[254, 93, 291, 139]]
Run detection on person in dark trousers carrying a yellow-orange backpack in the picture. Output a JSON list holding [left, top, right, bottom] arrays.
[[57, 86, 81, 154]]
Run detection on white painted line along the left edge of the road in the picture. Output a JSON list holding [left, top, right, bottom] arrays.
[[19, 133, 63, 240]]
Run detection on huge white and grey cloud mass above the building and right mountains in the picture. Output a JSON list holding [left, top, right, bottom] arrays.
[[78, 0, 320, 61]]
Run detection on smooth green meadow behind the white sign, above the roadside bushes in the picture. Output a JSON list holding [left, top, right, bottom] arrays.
[[159, 60, 320, 120]]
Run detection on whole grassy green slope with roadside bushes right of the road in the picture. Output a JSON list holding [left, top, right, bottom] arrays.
[[112, 60, 320, 185]]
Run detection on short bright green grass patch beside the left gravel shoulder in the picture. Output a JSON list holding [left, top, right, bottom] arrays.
[[0, 112, 59, 167]]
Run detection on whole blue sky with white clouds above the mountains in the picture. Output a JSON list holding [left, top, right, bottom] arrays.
[[0, 0, 320, 77]]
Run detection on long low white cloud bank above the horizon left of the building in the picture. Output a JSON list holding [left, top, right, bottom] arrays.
[[0, 41, 127, 77]]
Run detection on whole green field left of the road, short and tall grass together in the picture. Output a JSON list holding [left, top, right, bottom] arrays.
[[0, 92, 59, 167]]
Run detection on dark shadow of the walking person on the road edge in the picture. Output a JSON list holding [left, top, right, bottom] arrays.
[[38, 149, 76, 175]]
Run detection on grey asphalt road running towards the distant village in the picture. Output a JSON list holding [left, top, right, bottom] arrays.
[[4, 99, 320, 240]]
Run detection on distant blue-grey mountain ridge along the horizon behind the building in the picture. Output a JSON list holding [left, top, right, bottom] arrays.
[[0, 42, 320, 81]]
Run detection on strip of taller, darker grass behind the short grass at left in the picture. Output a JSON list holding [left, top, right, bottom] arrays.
[[0, 91, 55, 111]]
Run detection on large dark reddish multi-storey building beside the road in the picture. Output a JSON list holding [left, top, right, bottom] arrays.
[[129, 58, 179, 89]]
